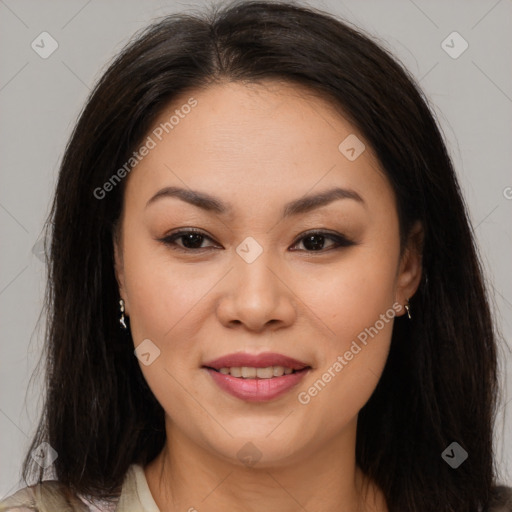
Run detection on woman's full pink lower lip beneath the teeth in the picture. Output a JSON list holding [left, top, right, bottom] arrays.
[[206, 368, 309, 402]]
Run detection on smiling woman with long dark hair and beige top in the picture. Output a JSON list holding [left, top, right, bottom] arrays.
[[0, 2, 512, 512]]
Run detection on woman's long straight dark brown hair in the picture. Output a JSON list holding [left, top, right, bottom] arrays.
[[19, 1, 496, 512]]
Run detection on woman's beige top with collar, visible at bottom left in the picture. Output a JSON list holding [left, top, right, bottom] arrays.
[[0, 464, 160, 512]]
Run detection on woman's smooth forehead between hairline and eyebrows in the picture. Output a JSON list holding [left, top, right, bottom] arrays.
[[126, 81, 392, 214]]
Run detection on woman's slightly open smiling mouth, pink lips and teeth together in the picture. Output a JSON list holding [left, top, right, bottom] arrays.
[[203, 353, 311, 402]]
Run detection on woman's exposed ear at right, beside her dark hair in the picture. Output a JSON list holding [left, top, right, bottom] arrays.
[[395, 221, 424, 316]]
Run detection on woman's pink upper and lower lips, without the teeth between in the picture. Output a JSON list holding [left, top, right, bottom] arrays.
[[203, 353, 311, 402]]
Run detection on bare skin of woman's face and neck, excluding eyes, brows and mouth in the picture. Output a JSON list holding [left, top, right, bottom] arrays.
[[114, 81, 421, 512]]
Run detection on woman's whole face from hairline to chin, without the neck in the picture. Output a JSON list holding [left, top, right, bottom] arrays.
[[115, 81, 420, 466]]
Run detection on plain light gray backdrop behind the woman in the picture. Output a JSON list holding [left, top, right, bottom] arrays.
[[0, 0, 512, 496]]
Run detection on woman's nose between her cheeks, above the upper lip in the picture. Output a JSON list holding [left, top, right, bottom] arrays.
[[217, 247, 297, 332]]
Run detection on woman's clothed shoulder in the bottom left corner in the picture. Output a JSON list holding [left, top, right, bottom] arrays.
[[0, 480, 115, 512]]
